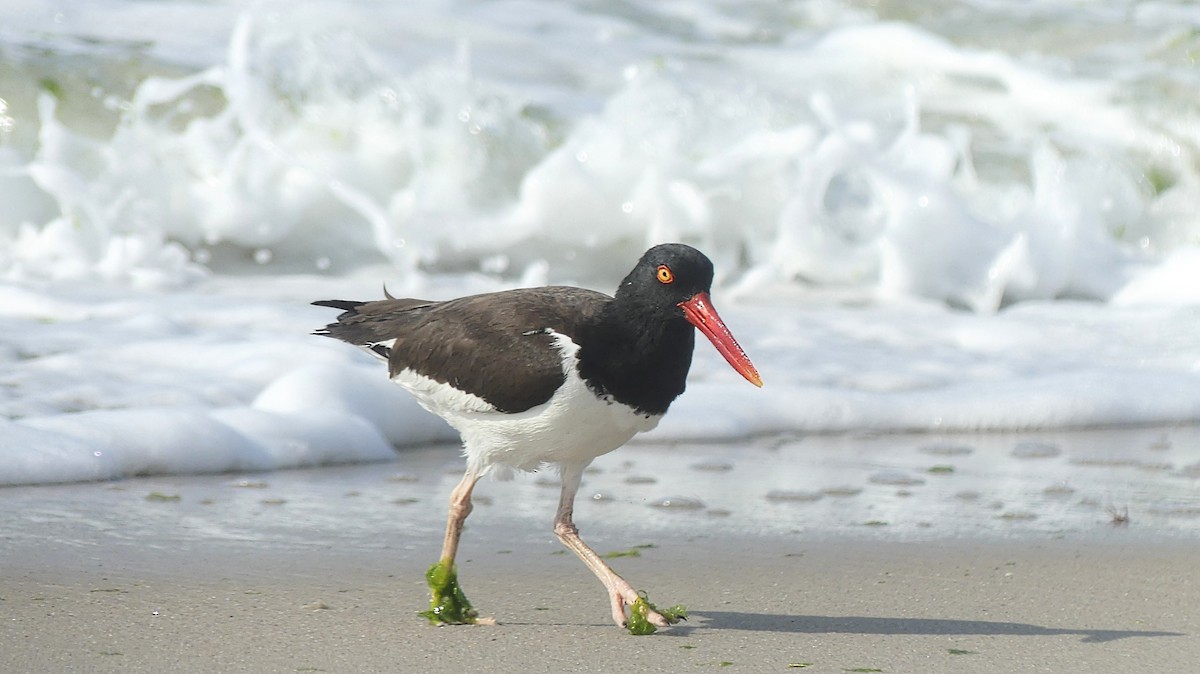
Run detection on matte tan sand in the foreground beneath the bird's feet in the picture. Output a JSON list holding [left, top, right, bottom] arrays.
[[0, 532, 1200, 673]]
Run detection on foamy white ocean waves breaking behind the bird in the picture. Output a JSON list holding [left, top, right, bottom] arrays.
[[0, 0, 1200, 498]]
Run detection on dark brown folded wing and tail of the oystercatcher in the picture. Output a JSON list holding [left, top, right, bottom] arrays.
[[314, 287, 611, 413]]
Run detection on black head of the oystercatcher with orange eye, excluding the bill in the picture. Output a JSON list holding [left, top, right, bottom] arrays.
[[617, 243, 713, 318]]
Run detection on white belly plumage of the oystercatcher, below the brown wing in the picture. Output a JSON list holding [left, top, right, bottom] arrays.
[[392, 331, 661, 477]]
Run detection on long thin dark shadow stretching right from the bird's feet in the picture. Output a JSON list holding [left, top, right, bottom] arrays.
[[691, 610, 1186, 643]]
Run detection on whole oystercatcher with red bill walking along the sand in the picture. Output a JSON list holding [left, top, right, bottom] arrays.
[[313, 243, 762, 631]]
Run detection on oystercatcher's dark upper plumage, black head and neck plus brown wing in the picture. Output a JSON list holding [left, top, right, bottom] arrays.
[[313, 243, 713, 415]]
